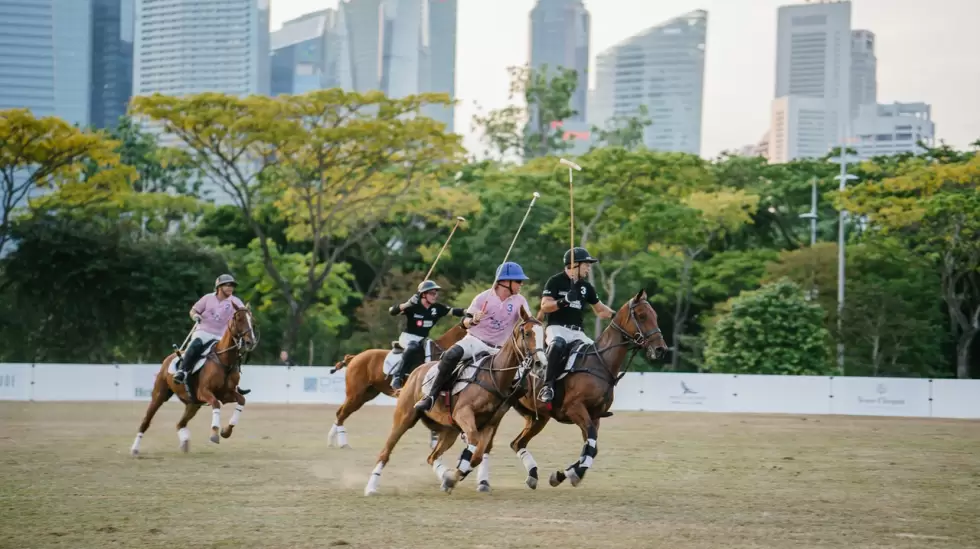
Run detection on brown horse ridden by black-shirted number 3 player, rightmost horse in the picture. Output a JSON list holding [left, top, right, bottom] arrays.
[[502, 290, 667, 489]]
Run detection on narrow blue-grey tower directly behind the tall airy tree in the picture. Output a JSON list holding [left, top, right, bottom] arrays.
[[530, 0, 591, 122]]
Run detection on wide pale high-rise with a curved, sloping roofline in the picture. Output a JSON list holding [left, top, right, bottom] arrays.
[[589, 10, 708, 154]]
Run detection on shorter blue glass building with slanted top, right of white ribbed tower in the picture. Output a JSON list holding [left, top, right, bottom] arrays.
[[269, 9, 337, 95]]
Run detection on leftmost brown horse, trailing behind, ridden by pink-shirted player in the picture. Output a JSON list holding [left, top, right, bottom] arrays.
[[130, 302, 258, 456]]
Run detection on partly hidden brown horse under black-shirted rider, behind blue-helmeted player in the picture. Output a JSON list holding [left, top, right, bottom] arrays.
[[327, 323, 466, 448]]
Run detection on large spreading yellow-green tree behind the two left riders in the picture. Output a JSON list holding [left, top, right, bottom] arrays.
[[133, 88, 462, 351]]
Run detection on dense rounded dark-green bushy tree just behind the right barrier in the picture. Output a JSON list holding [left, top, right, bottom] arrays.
[[704, 280, 833, 375]]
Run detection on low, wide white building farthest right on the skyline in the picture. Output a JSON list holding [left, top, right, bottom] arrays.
[[849, 103, 936, 158]]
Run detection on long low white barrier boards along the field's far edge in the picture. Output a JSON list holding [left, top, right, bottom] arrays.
[[0, 364, 980, 419]]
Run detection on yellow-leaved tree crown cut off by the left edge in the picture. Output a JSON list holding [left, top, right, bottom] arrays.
[[0, 109, 132, 256]]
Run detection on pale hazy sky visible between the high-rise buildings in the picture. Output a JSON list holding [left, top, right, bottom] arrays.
[[271, 0, 980, 158]]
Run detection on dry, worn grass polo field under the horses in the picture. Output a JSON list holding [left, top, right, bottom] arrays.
[[0, 402, 980, 549]]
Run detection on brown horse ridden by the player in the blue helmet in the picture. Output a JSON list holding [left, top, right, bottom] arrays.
[[364, 307, 548, 496]]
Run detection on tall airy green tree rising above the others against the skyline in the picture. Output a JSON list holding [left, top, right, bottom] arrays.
[[473, 65, 578, 158]]
